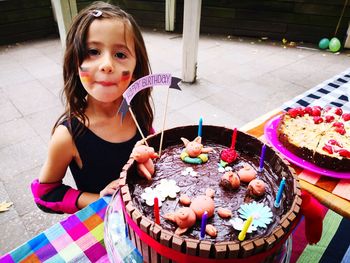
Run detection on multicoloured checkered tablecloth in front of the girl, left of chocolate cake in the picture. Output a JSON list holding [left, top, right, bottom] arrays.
[[0, 197, 110, 263]]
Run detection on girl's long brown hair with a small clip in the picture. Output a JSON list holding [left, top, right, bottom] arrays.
[[52, 2, 153, 138]]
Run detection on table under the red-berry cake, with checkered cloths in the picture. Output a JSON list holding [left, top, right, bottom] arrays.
[[241, 69, 350, 218]]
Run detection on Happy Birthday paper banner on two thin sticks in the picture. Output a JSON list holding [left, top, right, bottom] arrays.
[[118, 73, 181, 147]]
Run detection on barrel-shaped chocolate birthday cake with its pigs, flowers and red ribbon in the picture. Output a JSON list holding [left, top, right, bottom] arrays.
[[120, 126, 301, 262]]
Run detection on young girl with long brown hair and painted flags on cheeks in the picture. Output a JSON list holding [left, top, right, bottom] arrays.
[[31, 2, 153, 213]]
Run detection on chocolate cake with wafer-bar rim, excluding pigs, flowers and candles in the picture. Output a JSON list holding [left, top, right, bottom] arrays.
[[117, 126, 301, 262]]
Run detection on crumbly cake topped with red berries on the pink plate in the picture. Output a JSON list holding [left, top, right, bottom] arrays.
[[277, 106, 350, 171]]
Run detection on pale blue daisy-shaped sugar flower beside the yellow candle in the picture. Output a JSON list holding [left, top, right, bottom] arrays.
[[238, 201, 272, 228]]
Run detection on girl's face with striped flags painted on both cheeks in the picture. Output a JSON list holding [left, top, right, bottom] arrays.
[[79, 19, 136, 103]]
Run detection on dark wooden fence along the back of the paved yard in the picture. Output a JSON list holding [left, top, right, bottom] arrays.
[[0, 0, 350, 45]]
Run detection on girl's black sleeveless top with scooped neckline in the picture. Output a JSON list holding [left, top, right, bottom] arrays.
[[62, 118, 141, 193]]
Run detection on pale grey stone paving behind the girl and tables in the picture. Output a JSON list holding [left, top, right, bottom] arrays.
[[0, 31, 350, 255]]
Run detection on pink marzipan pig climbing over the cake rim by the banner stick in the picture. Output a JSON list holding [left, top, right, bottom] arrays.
[[131, 145, 158, 180]]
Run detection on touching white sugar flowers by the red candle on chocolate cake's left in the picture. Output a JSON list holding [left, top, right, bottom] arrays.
[[141, 179, 180, 207]]
